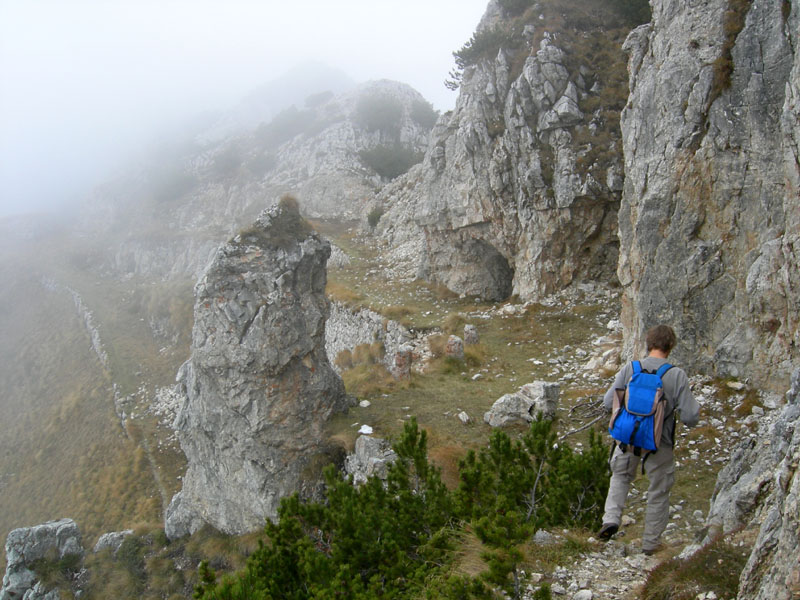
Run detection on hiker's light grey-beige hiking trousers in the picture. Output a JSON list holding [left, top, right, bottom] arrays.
[[603, 447, 675, 550]]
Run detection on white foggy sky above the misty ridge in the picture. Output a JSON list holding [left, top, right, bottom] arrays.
[[0, 0, 488, 217]]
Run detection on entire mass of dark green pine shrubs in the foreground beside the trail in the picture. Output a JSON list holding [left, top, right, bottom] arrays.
[[195, 419, 608, 600]]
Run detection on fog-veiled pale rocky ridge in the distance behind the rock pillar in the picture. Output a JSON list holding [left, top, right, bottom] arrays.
[[82, 80, 438, 279]]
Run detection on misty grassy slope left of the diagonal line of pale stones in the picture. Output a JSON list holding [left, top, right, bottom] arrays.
[[0, 255, 160, 560]]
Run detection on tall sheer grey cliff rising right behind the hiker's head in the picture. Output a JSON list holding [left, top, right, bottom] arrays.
[[617, 0, 800, 389]]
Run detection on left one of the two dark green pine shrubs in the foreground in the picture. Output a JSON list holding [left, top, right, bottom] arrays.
[[195, 420, 451, 600]]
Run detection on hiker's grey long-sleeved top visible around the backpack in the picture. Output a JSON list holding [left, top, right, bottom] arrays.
[[603, 356, 700, 446]]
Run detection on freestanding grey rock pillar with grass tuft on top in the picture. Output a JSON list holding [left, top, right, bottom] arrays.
[[166, 199, 346, 538]]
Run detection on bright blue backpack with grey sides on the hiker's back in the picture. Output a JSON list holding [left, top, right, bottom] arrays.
[[608, 360, 672, 455]]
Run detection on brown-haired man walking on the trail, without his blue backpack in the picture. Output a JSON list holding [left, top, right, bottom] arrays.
[[598, 325, 700, 555]]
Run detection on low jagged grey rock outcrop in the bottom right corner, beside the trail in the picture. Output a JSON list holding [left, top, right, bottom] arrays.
[[708, 370, 800, 600]]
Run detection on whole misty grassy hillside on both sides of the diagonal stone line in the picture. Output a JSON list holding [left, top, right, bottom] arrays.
[[0, 230, 191, 568]]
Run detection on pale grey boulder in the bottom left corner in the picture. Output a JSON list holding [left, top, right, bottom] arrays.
[[0, 519, 84, 600]]
